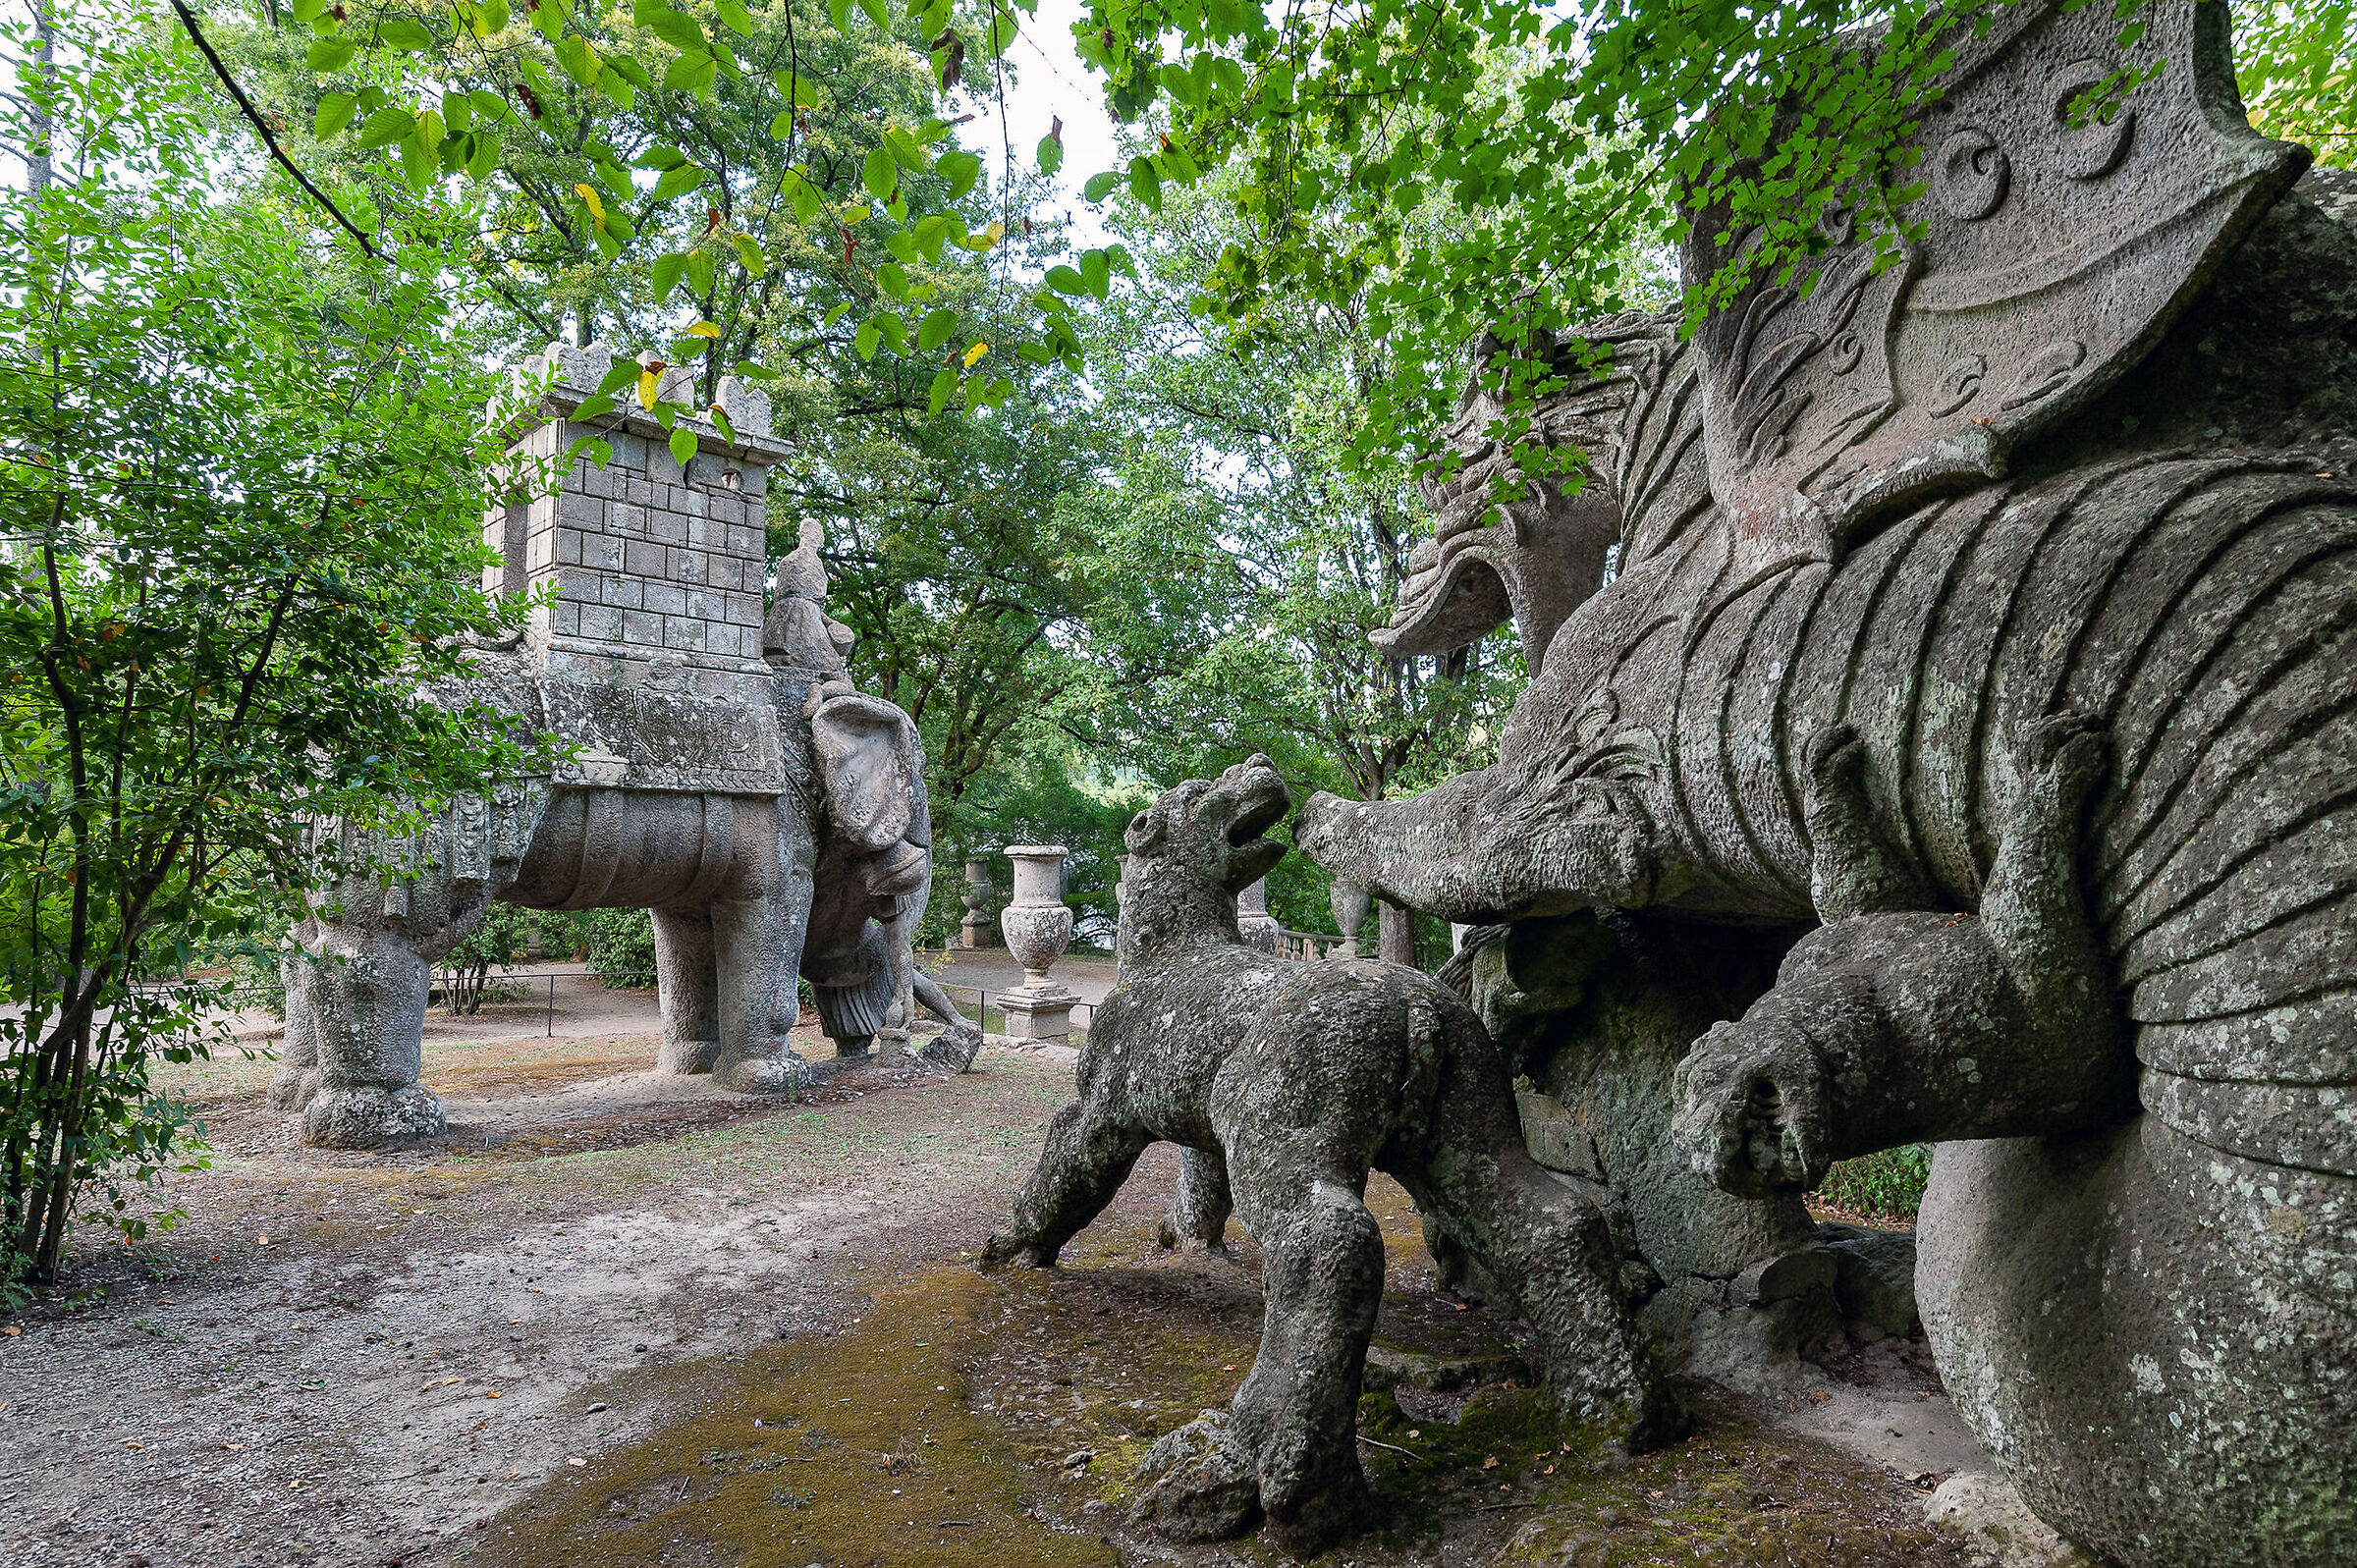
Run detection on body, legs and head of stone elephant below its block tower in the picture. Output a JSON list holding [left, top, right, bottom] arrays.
[[271, 651, 955, 1149]]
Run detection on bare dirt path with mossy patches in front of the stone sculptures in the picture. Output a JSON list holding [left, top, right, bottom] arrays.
[[0, 1035, 2007, 1568]]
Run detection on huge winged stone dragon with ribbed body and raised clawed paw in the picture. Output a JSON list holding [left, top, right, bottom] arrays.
[[1298, 0, 2357, 1568]]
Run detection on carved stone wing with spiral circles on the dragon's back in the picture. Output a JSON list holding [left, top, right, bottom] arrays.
[[1685, 0, 2308, 568]]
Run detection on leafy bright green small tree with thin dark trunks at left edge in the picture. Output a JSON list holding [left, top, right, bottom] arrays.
[[0, 17, 539, 1280]]
